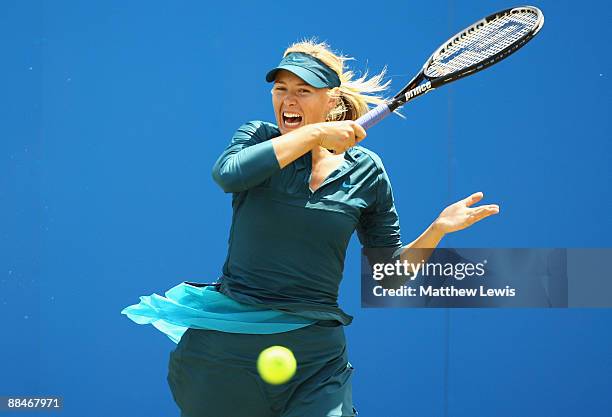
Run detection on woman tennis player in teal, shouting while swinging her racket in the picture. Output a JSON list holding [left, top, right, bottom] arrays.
[[124, 41, 499, 417]]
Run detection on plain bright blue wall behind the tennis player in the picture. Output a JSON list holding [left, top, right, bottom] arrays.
[[0, 0, 612, 417]]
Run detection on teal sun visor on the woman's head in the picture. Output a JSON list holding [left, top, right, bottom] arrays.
[[266, 52, 340, 88]]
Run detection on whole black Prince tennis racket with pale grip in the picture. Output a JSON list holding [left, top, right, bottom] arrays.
[[356, 6, 544, 129]]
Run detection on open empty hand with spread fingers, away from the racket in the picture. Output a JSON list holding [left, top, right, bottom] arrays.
[[433, 192, 499, 233]]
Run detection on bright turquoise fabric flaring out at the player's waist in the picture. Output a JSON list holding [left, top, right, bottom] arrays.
[[121, 282, 317, 343]]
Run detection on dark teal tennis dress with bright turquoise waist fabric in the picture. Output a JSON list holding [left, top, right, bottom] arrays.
[[122, 121, 401, 417]]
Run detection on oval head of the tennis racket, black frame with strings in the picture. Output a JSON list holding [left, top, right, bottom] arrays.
[[422, 6, 544, 81]]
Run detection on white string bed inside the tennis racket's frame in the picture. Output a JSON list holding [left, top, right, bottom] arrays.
[[425, 10, 539, 78]]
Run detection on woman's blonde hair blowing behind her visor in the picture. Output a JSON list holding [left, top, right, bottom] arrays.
[[283, 39, 391, 121]]
